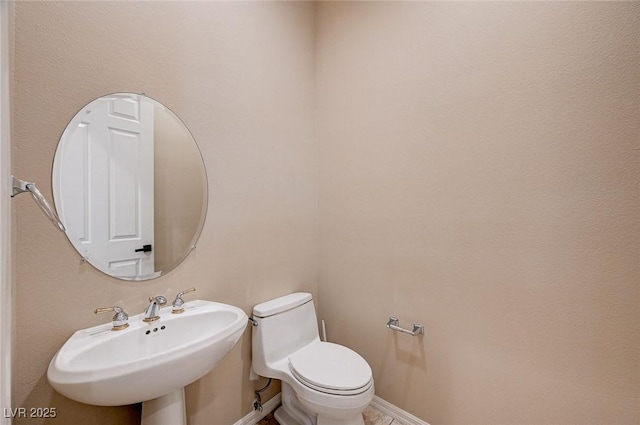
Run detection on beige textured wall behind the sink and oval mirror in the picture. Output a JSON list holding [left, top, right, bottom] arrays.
[[12, 2, 319, 425]]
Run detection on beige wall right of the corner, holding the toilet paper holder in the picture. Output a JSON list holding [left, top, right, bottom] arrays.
[[316, 2, 640, 425]]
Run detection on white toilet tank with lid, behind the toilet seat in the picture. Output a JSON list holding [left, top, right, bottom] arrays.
[[252, 292, 319, 376]]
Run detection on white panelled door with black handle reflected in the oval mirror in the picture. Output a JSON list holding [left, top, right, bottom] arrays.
[[60, 95, 155, 279]]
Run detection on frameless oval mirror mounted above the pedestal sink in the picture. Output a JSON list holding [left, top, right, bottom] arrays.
[[52, 93, 208, 280]]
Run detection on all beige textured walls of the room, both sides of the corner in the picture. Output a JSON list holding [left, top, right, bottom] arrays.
[[12, 2, 640, 425]]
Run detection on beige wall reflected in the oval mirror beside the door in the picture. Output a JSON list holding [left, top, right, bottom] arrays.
[[153, 106, 207, 273]]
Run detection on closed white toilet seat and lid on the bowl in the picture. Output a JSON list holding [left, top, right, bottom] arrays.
[[289, 341, 373, 396]]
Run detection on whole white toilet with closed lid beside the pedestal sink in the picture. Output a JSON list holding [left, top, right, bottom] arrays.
[[252, 292, 374, 425]]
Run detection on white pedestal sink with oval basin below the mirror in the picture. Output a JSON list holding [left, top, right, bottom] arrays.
[[47, 300, 247, 425]]
